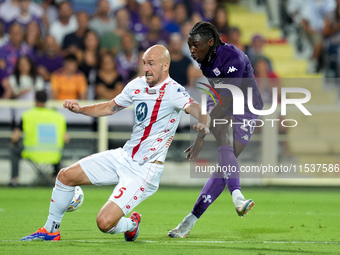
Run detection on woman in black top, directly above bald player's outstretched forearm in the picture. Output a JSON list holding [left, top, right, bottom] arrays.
[[96, 53, 124, 100]]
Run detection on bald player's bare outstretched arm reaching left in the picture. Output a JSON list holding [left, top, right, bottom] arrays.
[[64, 99, 124, 117]]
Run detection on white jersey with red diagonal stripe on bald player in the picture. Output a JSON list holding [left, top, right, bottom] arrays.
[[114, 76, 194, 164]]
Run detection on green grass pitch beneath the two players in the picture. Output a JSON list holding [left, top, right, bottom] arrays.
[[0, 186, 340, 255]]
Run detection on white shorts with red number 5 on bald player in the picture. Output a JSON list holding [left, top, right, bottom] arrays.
[[78, 148, 164, 215]]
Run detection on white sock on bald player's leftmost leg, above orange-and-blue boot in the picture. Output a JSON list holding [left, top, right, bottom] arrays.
[[44, 179, 75, 233]]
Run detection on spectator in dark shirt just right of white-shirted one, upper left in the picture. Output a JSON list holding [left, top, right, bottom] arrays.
[[61, 12, 89, 55]]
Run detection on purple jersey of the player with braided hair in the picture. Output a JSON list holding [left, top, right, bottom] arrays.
[[201, 43, 263, 116]]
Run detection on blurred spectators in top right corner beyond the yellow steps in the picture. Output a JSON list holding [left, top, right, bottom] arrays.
[[258, 0, 340, 78]]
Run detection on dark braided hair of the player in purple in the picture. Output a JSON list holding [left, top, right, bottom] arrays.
[[189, 21, 222, 48]]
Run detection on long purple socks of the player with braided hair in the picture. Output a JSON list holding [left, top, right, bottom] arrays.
[[191, 145, 241, 218]]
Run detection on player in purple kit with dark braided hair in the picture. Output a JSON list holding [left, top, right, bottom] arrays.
[[168, 21, 263, 238]]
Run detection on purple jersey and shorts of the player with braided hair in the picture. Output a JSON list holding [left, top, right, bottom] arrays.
[[201, 43, 263, 145]]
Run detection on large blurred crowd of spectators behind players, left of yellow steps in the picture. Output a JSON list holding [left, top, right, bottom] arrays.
[[0, 0, 282, 100]]
